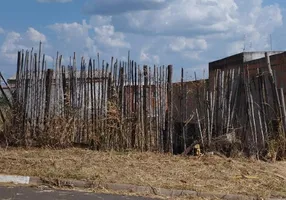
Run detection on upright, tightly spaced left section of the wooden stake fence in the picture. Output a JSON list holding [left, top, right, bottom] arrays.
[[1, 46, 173, 151]]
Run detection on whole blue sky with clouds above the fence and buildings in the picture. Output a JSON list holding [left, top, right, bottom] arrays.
[[0, 0, 286, 77]]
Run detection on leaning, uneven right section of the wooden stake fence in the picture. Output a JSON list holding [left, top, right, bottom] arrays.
[[174, 54, 286, 157]]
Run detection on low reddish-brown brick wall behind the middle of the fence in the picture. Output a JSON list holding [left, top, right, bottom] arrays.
[[124, 80, 207, 123]]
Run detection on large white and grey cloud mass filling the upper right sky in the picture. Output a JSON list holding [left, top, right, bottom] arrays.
[[112, 0, 283, 65]]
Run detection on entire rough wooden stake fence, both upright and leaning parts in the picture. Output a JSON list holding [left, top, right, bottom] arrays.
[[0, 48, 286, 158]]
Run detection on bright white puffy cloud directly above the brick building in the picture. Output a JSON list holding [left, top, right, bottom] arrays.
[[228, 0, 283, 53]]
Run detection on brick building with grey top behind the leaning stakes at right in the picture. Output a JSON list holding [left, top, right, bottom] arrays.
[[209, 52, 286, 144]]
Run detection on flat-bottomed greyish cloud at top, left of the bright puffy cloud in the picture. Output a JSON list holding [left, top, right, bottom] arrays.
[[120, 0, 238, 36]]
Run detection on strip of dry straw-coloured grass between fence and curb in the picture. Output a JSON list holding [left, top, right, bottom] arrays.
[[0, 148, 286, 197]]
